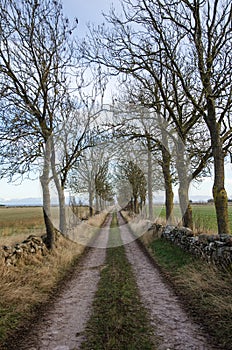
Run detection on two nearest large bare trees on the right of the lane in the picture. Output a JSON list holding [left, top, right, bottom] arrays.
[[81, 0, 232, 233]]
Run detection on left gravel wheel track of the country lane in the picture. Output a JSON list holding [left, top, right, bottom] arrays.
[[21, 218, 111, 350]]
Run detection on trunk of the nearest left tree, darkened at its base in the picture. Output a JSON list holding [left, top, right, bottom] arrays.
[[40, 139, 54, 249]]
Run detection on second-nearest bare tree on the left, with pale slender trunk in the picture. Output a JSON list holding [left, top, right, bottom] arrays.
[[51, 70, 107, 234]]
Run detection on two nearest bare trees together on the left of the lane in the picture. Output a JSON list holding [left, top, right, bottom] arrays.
[[0, 0, 105, 248]]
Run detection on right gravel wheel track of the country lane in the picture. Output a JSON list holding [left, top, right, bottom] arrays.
[[118, 215, 219, 350]]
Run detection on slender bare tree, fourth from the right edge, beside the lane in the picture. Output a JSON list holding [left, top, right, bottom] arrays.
[[111, 100, 162, 220]]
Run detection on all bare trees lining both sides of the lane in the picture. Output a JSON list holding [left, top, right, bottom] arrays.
[[0, 0, 232, 248]]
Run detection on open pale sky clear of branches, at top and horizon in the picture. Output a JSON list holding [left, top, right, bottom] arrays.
[[0, 0, 232, 204]]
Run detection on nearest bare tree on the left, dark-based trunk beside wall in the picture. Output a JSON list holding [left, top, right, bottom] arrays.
[[0, 0, 77, 248]]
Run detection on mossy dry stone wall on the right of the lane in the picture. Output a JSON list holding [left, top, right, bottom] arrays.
[[148, 224, 232, 269]]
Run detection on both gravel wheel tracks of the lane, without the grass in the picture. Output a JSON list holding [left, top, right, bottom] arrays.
[[13, 213, 219, 350]]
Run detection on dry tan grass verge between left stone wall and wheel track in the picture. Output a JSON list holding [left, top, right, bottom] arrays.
[[0, 213, 106, 350]]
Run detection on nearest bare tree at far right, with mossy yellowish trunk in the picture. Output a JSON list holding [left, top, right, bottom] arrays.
[[128, 0, 232, 233]]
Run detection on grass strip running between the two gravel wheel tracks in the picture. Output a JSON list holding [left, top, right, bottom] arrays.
[[81, 213, 155, 350]]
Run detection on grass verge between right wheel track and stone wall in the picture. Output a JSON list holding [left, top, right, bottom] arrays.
[[145, 237, 232, 350]]
